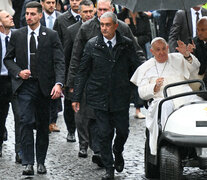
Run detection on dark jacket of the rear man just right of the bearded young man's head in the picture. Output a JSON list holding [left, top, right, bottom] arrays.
[[53, 9, 76, 45]]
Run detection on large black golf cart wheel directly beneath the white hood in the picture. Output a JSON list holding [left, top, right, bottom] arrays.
[[160, 145, 183, 180]]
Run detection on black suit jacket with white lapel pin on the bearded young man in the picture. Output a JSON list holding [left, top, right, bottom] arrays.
[[4, 26, 65, 96]]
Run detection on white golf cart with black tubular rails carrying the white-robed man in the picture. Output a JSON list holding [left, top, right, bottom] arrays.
[[145, 80, 207, 180]]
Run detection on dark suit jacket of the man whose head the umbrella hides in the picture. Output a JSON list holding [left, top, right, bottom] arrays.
[[169, 8, 207, 52]]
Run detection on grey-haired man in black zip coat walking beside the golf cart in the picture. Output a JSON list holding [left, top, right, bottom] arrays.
[[72, 12, 141, 180]]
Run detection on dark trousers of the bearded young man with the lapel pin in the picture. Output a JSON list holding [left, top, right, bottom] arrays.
[[18, 79, 50, 165]]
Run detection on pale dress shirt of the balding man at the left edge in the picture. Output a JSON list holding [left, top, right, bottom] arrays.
[[0, 31, 11, 76]]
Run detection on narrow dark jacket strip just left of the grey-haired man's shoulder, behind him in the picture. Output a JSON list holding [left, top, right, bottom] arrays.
[[64, 21, 82, 79]]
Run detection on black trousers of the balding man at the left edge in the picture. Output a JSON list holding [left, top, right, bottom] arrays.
[[0, 76, 20, 152]]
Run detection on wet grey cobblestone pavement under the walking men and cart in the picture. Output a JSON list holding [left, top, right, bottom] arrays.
[[0, 107, 207, 180]]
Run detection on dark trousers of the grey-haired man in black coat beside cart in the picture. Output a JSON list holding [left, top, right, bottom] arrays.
[[94, 108, 129, 168]]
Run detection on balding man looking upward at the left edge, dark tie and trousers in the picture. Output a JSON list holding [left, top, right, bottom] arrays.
[[0, 11, 21, 163]]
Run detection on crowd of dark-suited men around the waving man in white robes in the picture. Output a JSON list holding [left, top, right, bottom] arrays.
[[0, 0, 207, 180]]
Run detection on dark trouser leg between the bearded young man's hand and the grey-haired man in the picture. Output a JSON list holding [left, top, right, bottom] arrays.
[[63, 98, 76, 134]]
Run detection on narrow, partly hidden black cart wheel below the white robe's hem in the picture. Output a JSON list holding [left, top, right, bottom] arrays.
[[144, 137, 159, 178]]
